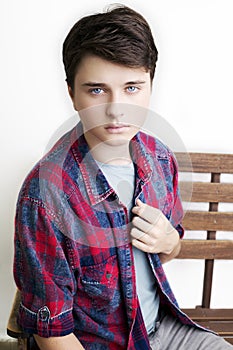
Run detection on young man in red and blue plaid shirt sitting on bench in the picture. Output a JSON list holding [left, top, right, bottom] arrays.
[[14, 6, 231, 350]]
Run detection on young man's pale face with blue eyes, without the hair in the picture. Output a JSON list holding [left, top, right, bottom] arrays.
[[69, 55, 151, 148]]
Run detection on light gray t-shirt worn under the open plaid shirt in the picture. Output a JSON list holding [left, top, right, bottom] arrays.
[[97, 162, 159, 334]]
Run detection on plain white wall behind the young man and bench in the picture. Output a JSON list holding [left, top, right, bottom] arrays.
[[0, 0, 233, 332]]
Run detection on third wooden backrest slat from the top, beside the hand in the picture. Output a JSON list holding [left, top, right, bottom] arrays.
[[182, 210, 233, 231]]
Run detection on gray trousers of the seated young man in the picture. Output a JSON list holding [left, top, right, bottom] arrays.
[[149, 315, 233, 350]]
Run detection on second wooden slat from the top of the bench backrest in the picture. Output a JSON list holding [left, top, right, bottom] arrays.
[[179, 181, 233, 203]]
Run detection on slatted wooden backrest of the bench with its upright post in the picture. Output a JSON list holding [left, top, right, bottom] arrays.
[[176, 153, 233, 308]]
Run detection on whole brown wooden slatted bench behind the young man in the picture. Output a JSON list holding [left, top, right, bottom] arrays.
[[7, 153, 233, 350]]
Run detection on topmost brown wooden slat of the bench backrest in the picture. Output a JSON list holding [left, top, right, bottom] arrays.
[[175, 152, 233, 174]]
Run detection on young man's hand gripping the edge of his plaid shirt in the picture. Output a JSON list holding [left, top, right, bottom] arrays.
[[131, 199, 180, 262]]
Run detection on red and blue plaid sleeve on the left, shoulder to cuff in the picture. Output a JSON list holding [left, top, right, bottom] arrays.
[[14, 197, 76, 337]]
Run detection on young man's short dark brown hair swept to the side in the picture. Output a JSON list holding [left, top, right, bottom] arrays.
[[63, 5, 158, 89]]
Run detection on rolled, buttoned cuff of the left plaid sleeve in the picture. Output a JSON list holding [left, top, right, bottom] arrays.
[[18, 303, 74, 338]]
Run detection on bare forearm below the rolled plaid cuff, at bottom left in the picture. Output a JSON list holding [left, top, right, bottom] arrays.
[[34, 333, 84, 350]]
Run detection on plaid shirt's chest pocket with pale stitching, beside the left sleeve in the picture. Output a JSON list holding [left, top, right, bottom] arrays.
[[78, 255, 121, 314]]
